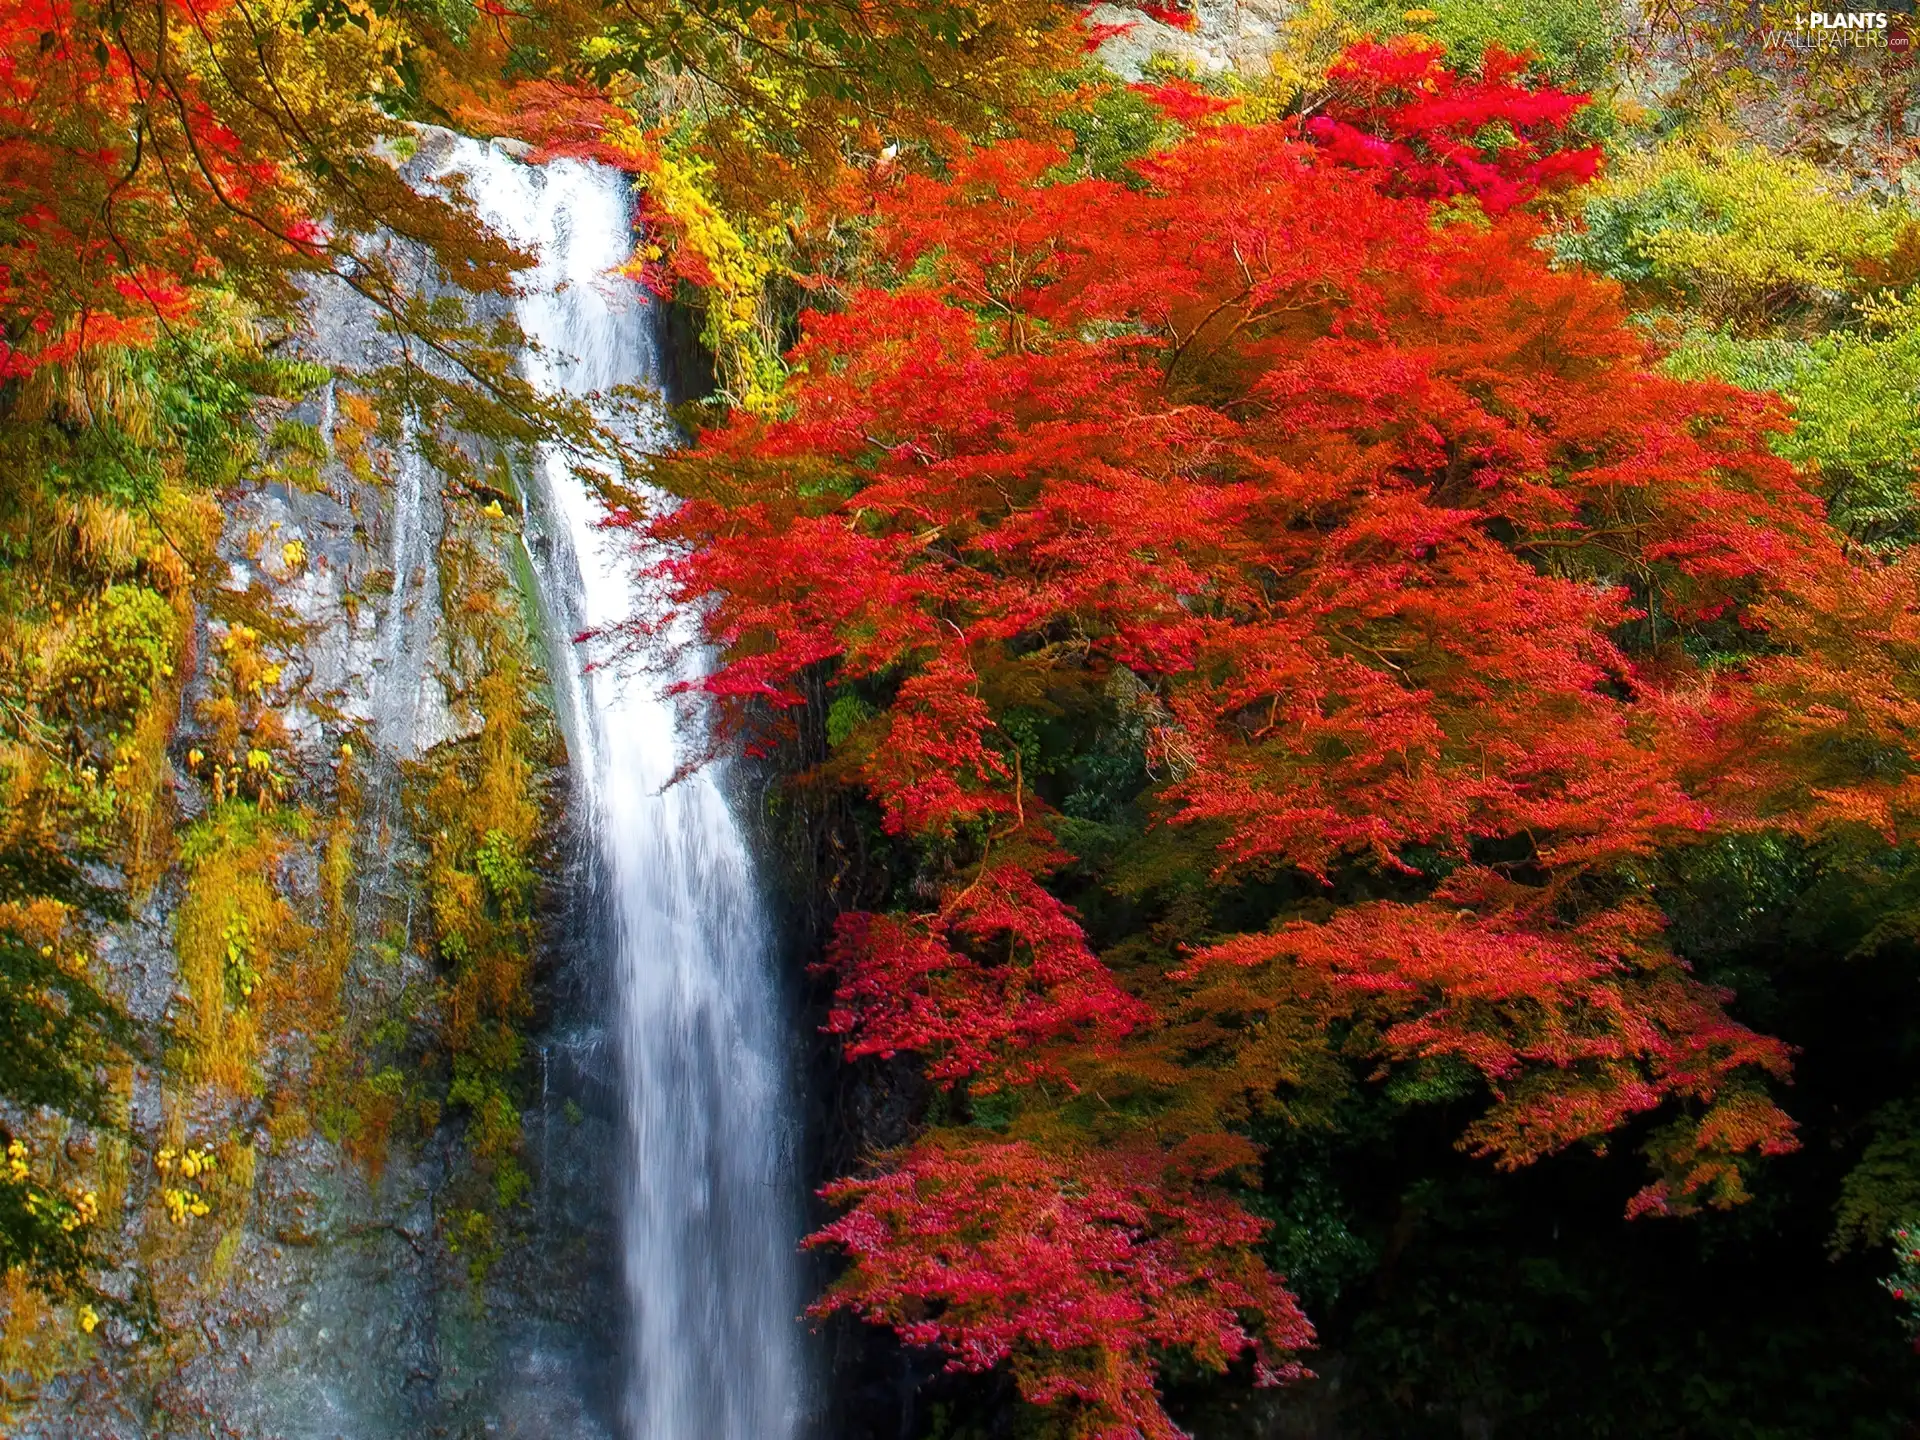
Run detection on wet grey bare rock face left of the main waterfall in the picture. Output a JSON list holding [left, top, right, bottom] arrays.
[[0, 127, 620, 1440]]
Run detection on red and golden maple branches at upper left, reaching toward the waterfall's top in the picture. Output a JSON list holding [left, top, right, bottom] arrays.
[[0, 0, 524, 384]]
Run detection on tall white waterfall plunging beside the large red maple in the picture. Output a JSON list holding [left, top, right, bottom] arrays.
[[442, 140, 801, 1440]]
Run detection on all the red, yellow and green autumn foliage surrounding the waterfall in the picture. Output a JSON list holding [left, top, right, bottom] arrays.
[[0, 0, 1920, 1440]]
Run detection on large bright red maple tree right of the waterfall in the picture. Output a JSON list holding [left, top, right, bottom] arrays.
[[655, 48, 1891, 1436]]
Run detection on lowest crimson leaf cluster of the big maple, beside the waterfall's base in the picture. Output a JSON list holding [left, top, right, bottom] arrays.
[[812, 1140, 1313, 1440]]
